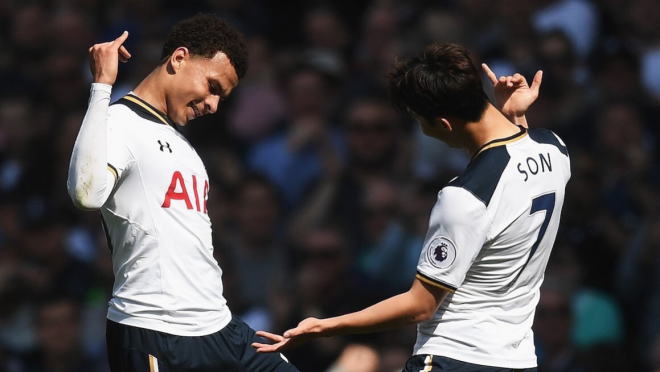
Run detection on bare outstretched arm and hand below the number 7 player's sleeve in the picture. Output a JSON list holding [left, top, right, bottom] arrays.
[[252, 279, 449, 353]]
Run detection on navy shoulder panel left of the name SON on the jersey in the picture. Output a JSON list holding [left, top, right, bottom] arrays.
[[443, 146, 511, 206]]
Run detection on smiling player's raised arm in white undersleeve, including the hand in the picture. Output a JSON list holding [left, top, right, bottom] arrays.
[[67, 32, 131, 210]]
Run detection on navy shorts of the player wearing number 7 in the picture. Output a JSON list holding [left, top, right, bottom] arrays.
[[403, 355, 537, 372]]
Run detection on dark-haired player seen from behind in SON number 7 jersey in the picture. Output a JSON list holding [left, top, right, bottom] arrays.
[[253, 44, 570, 372]]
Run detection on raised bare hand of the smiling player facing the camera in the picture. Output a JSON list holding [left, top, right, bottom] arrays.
[[89, 31, 131, 85]]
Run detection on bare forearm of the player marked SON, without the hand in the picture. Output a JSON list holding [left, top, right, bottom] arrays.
[[319, 291, 436, 337]]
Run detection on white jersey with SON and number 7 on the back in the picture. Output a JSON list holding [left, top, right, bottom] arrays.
[[414, 128, 570, 368]]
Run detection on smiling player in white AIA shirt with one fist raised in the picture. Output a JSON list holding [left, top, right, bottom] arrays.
[[68, 15, 297, 372]]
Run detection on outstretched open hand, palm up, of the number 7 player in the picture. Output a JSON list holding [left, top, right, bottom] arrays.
[[252, 318, 321, 353]]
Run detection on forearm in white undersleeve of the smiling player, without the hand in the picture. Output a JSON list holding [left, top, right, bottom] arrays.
[[67, 84, 114, 210]]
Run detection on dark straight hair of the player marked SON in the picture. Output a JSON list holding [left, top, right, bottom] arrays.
[[389, 44, 489, 122]]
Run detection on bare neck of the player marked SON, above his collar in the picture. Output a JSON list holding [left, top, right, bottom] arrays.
[[462, 103, 520, 156]]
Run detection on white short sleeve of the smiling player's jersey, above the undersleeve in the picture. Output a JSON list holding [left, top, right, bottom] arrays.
[[108, 107, 134, 180]]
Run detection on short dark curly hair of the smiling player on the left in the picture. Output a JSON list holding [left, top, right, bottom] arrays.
[[161, 13, 248, 78]]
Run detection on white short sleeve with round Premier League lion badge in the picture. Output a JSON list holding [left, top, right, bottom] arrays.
[[417, 186, 491, 292]]
